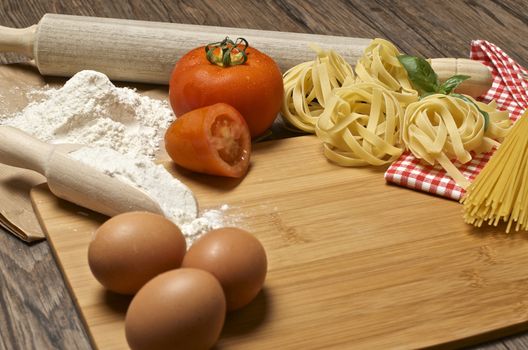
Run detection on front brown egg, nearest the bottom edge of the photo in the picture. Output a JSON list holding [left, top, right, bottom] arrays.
[[125, 268, 226, 350]]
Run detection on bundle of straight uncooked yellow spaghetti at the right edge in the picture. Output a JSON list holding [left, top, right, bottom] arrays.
[[461, 110, 528, 232]]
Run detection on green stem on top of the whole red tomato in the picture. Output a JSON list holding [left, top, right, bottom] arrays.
[[205, 36, 249, 67]]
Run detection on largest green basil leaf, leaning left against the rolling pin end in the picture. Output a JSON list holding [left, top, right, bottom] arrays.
[[398, 55, 439, 95]]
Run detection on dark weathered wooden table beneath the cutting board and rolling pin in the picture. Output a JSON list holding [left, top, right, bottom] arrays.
[[0, 0, 528, 350]]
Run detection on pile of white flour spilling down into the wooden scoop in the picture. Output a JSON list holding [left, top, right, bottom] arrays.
[[0, 70, 232, 247]]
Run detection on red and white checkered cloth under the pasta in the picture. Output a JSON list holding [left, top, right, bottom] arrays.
[[385, 40, 528, 200]]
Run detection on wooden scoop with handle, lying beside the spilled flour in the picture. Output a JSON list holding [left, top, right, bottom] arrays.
[[0, 125, 163, 216]]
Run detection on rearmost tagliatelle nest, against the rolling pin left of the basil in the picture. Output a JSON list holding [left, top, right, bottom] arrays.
[[355, 38, 418, 106]]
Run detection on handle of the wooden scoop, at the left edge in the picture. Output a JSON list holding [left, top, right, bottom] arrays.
[[0, 125, 54, 175]]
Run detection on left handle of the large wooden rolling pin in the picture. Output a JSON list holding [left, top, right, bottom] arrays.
[[0, 24, 37, 58]]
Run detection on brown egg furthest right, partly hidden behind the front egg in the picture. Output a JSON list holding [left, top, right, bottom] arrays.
[[182, 227, 268, 310]]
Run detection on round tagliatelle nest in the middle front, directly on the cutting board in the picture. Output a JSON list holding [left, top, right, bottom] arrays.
[[315, 83, 403, 166]]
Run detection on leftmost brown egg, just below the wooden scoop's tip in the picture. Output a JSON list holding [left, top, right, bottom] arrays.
[[88, 212, 186, 294]]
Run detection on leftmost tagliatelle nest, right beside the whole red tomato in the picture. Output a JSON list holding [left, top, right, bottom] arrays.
[[281, 46, 354, 133]]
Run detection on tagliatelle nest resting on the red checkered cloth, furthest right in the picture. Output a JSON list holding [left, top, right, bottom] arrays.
[[402, 94, 511, 188]]
